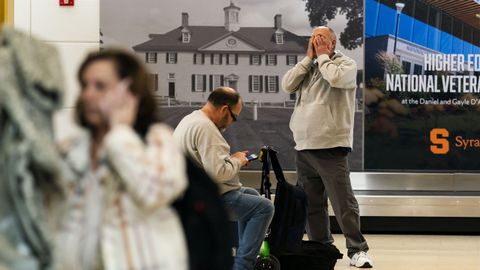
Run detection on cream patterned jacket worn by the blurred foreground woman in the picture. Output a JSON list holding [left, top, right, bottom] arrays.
[[55, 124, 188, 270]]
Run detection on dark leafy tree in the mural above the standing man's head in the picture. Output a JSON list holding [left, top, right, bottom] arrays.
[[303, 0, 363, 50]]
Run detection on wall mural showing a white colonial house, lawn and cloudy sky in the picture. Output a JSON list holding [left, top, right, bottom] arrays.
[[100, 0, 363, 170]]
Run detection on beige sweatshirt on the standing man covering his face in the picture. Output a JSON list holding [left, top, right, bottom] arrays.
[[282, 52, 357, 151]]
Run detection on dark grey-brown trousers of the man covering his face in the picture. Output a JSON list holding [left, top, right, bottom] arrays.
[[296, 148, 368, 257]]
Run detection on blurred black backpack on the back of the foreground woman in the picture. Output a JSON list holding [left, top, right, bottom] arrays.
[[174, 158, 233, 270]]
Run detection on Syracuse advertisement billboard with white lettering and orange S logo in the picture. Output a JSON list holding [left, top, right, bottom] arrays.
[[364, 0, 480, 171]]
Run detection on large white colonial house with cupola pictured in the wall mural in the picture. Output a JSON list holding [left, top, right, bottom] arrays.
[[133, 3, 308, 103]]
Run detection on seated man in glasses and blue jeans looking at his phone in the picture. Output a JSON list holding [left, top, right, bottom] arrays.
[[174, 87, 273, 270]]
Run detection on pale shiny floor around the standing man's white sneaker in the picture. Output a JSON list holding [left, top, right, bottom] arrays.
[[334, 234, 480, 270]]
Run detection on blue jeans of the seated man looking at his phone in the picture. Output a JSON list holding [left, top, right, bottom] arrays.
[[222, 187, 273, 270]]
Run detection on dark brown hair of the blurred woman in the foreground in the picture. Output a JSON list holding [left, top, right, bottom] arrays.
[[75, 49, 157, 138]]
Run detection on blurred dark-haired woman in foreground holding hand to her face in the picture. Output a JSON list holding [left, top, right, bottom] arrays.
[[55, 50, 188, 270]]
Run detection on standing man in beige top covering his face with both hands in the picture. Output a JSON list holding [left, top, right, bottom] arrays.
[[282, 26, 373, 268]]
